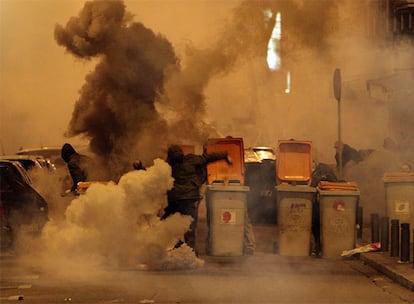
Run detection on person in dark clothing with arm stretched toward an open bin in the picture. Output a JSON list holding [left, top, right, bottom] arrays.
[[162, 145, 231, 251]]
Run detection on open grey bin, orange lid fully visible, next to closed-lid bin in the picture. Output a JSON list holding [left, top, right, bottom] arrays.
[[276, 140, 316, 256]]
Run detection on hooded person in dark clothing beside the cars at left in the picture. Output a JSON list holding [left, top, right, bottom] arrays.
[[61, 143, 90, 192]]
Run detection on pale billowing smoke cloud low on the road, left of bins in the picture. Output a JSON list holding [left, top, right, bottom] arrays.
[[34, 159, 203, 275]]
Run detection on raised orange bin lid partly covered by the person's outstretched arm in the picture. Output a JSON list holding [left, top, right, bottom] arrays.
[[205, 137, 244, 185]]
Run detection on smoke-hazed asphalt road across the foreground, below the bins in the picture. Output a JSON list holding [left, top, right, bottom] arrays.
[[0, 252, 414, 304]]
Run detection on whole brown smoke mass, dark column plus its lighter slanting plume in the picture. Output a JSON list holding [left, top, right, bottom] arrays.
[[55, 1, 278, 178]]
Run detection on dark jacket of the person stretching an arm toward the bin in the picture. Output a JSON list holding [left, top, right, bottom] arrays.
[[167, 146, 228, 201]]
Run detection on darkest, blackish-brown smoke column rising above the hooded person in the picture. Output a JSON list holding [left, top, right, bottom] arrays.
[[55, 1, 177, 178]]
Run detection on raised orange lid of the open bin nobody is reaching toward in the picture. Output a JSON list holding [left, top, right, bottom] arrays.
[[276, 140, 312, 185]]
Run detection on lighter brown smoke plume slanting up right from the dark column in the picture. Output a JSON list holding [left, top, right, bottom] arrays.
[[159, 1, 274, 143]]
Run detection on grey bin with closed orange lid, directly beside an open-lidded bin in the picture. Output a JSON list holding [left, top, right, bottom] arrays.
[[318, 181, 360, 258]]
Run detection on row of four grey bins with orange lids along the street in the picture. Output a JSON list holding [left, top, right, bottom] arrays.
[[205, 137, 414, 258]]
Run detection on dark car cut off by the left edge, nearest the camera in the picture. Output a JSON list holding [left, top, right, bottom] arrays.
[[0, 160, 48, 247]]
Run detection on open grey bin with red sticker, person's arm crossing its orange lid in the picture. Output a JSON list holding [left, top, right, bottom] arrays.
[[206, 138, 249, 256]]
